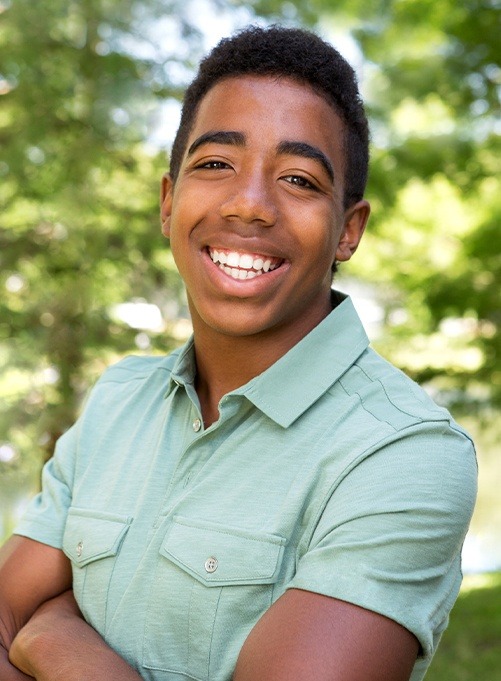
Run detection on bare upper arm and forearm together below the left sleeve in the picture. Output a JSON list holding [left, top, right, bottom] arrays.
[[0, 537, 141, 681]]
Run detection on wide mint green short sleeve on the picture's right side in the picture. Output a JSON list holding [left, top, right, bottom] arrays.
[[289, 424, 477, 678]]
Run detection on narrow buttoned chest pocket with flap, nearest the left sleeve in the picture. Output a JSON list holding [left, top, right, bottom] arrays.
[[63, 507, 132, 633]]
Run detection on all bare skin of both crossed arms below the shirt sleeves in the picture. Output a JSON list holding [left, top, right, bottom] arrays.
[[0, 537, 418, 681]]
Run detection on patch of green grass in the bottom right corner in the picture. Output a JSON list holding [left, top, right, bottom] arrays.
[[426, 573, 501, 681]]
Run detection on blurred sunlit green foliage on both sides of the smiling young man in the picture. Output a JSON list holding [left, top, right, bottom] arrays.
[[0, 0, 501, 524]]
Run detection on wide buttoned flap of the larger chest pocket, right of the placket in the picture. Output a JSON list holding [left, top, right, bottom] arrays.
[[160, 516, 286, 586]]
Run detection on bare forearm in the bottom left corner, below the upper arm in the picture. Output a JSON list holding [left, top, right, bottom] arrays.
[[9, 594, 141, 681]]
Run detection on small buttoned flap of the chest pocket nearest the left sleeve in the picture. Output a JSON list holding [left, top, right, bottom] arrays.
[[63, 507, 132, 567]]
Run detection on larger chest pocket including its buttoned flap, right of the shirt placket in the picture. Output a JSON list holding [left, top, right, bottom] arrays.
[[143, 516, 285, 681]]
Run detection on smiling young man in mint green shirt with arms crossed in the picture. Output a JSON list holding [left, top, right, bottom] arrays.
[[0, 27, 476, 681]]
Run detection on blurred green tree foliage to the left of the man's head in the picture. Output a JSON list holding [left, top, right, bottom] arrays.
[[0, 0, 196, 520]]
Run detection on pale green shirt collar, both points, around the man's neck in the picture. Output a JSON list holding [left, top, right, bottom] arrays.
[[167, 292, 369, 428]]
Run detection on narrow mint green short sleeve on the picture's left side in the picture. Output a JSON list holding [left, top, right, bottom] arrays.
[[14, 424, 78, 548]]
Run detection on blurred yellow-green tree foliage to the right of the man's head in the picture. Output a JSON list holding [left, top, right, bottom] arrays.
[[327, 0, 501, 413]]
